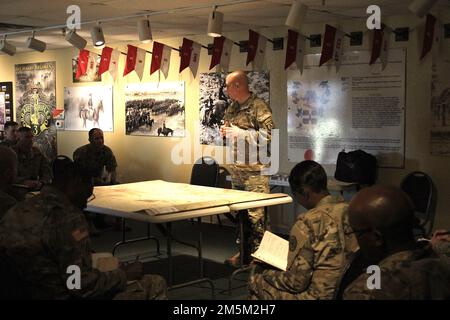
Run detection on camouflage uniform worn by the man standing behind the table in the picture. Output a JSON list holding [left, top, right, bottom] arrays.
[[224, 93, 273, 252]]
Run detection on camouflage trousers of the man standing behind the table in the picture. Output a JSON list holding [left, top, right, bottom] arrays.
[[231, 170, 270, 257]]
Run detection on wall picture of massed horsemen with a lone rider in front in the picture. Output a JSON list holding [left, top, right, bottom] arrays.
[[125, 81, 185, 137]]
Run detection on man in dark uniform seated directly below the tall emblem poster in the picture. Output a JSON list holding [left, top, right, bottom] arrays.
[[14, 127, 52, 191]]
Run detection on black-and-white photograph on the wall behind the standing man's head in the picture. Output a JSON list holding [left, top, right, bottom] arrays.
[[199, 71, 270, 145]]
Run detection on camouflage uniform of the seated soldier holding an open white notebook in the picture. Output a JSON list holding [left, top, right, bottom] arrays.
[[249, 196, 358, 300]]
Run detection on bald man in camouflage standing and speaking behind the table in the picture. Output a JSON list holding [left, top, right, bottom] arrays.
[[220, 70, 273, 266]]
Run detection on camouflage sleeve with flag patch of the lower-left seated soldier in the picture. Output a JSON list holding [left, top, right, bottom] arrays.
[[49, 209, 127, 298]]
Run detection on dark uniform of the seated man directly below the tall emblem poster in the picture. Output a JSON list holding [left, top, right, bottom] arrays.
[[14, 146, 52, 184]]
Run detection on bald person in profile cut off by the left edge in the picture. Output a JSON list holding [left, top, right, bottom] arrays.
[[0, 146, 17, 220]]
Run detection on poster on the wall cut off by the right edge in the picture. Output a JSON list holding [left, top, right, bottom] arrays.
[[430, 53, 450, 157]]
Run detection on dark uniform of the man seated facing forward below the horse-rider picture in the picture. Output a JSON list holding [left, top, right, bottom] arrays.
[[73, 144, 117, 185]]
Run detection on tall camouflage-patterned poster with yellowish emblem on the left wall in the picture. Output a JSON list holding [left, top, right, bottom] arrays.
[[15, 61, 57, 160]]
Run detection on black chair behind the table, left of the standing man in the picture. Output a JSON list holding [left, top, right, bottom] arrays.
[[190, 157, 222, 225]]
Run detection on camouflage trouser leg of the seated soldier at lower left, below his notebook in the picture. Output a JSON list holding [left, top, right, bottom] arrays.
[[114, 275, 167, 300]]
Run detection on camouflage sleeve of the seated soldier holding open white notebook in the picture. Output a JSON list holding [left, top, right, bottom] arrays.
[[263, 220, 314, 294]]
